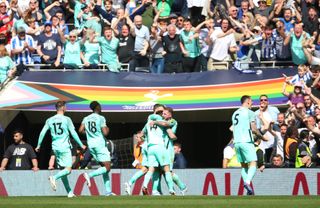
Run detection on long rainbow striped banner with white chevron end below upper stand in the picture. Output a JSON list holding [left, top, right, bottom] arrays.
[[0, 72, 287, 112]]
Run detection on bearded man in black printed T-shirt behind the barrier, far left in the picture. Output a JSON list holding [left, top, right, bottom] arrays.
[[0, 130, 39, 171]]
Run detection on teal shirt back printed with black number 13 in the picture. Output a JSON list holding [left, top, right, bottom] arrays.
[[46, 114, 74, 150]]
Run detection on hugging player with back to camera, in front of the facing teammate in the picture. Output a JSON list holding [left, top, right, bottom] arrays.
[[142, 104, 176, 195]]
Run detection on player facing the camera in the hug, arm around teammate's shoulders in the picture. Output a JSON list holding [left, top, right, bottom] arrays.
[[153, 107, 187, 195]]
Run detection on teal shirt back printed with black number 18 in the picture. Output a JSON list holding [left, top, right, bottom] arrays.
[[82, 113, 107, 148]]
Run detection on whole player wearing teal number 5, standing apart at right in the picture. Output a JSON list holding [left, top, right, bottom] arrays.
[[232, 95, 262, 195]]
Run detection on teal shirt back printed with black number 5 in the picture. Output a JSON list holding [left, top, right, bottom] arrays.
[[232, 107, 255, 143]]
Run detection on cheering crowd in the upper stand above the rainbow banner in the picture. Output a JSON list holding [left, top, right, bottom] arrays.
[[0, 0, 320, 82]]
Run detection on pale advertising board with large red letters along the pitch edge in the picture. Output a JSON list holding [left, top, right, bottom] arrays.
[[0, 169, 320, 196]]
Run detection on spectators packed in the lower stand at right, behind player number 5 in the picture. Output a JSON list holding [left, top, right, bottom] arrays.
[[223, 65, 320, 171]]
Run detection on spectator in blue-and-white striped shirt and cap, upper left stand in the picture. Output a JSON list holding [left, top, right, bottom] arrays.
[[11, 27, 35, 65]]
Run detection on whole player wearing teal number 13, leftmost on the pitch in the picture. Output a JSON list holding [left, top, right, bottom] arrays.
[[36, 101, 86, 197]]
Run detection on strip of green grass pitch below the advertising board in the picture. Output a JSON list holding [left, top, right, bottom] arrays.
[[0, 196, 320, 208]]
